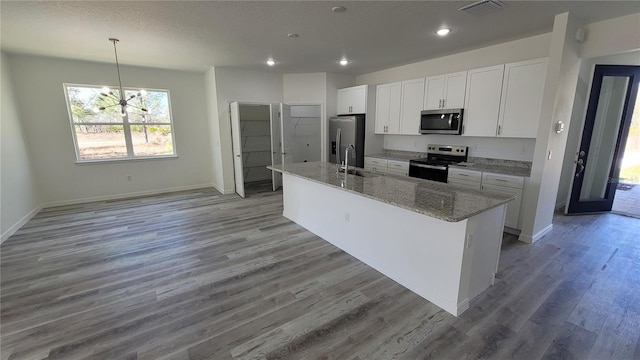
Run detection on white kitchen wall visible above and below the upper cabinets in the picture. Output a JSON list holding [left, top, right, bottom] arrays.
[[356, 34, 551, 161]]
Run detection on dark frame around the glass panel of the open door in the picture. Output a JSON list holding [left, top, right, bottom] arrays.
[[565, 64, 640, 214]]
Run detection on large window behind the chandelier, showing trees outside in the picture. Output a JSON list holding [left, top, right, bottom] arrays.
[[64, 84, 176, 162]]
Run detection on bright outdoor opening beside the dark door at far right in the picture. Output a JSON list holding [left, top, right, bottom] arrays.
[[611, 90, 640, 218]]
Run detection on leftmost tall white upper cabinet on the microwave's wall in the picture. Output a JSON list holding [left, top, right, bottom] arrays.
[[375, 82, 402, 134]]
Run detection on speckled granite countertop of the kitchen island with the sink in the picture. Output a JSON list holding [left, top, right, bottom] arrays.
[[267, 162, 515, 222]]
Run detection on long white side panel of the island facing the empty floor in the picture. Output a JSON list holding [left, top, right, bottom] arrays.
[[283, 174, 468, 315]]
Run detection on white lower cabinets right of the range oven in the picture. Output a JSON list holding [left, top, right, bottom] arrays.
[[447, 168, 524, 229]]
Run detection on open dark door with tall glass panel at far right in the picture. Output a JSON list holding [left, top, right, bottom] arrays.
[[567, 65, 640, 214]]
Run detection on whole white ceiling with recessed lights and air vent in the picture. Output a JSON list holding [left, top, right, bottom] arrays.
[[0, 1, 640, 75]]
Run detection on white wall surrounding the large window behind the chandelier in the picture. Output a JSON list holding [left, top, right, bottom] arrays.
[[9, 55, 212, 205]]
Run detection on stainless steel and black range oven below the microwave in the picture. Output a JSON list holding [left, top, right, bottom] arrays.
[[409, 145, 469, 182]]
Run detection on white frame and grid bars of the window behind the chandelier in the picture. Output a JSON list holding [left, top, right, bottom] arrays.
[[62, 83, 178, 164]]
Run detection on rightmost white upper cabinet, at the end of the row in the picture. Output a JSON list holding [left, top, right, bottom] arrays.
[[498, 58, 547, 138]]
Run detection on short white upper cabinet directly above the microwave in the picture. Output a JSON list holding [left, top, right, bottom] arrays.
[[423, 71, 467, 110]]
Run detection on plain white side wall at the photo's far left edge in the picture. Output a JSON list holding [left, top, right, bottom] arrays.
[[0, 53, 41, 242]]
